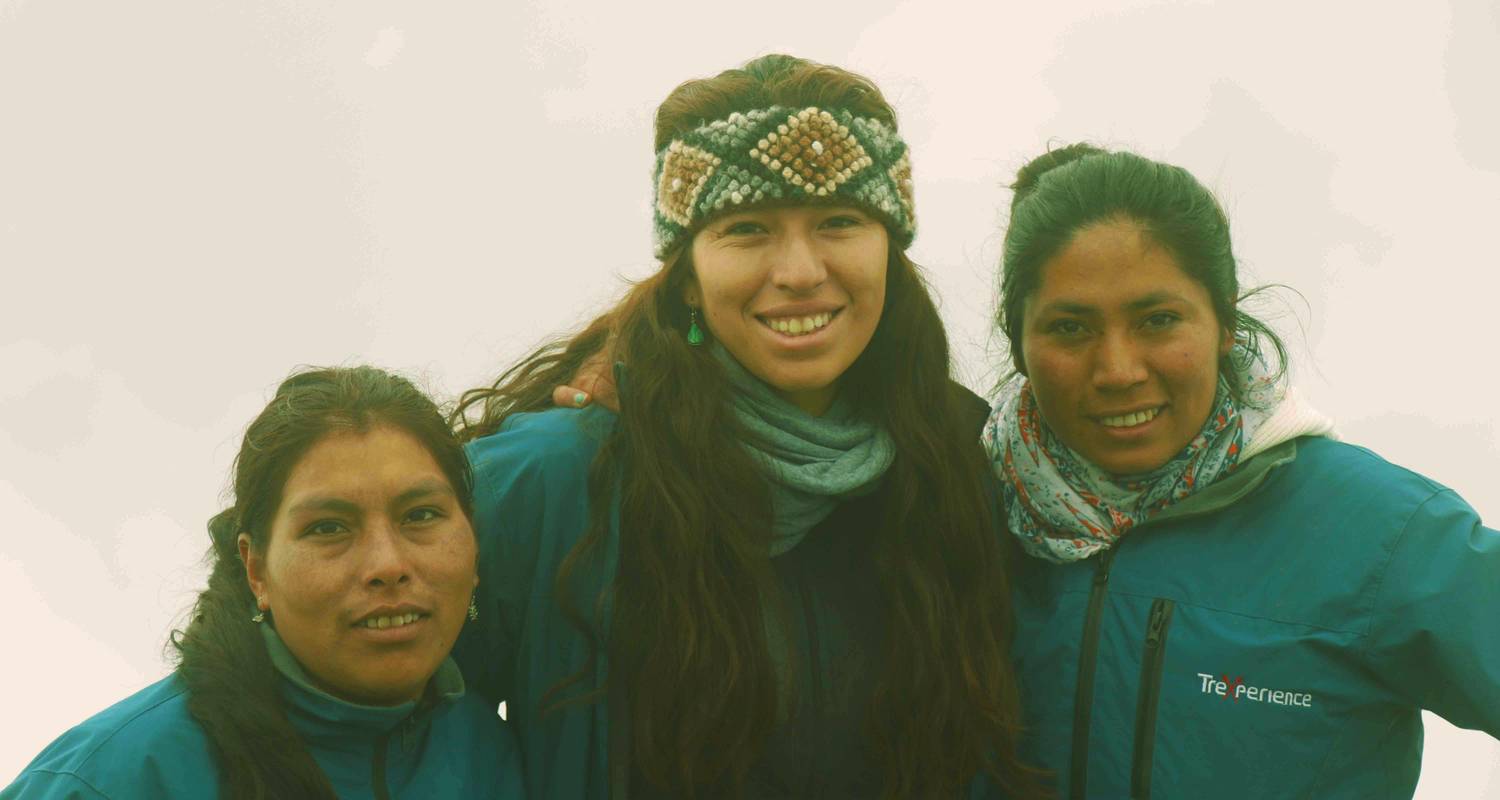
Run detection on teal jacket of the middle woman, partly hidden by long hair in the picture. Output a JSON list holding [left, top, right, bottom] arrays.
[[453, 401, 1002, 800]]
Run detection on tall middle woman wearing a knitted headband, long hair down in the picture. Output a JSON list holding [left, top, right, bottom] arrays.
[[444, 56, 1029, 798]]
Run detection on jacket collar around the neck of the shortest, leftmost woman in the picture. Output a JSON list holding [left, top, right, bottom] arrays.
[[260, 624, 464, 749]]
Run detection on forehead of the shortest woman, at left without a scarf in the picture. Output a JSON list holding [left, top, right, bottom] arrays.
[[282, 425, 447, 509]]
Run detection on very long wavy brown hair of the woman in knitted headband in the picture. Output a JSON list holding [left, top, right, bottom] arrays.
[[455, 56, 1034, 798]]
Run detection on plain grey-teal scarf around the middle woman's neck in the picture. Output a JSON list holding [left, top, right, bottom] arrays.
[[711, 342, 896, 555]]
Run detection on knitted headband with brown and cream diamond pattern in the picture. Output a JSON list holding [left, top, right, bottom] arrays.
[[653, 105, 917, 258]]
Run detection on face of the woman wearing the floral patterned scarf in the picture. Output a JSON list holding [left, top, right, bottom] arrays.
[[1020, 218, 1235, 474]]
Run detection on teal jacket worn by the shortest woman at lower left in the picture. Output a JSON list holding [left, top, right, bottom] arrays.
[[0, 633, 525, 800]]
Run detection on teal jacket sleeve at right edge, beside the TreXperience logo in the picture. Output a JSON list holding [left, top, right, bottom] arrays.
[[1368, 489, 1500, 737]]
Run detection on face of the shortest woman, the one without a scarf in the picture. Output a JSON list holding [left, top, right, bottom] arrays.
[[239, 425, 479, 705]]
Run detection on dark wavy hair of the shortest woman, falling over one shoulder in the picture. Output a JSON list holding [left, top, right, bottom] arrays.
[[171, 366, 471, 800]]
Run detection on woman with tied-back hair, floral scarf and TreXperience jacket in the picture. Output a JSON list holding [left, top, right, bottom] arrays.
[[986, 146, 1500, 798]]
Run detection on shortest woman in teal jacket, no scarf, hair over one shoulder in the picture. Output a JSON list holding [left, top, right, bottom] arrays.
[[0, 368, 522, 800]]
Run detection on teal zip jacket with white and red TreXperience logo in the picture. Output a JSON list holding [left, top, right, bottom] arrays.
[[1014, 438, 1500, 800]]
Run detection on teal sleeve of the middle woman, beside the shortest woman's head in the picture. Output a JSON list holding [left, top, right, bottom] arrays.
[[453, 410, 597, 708]]
